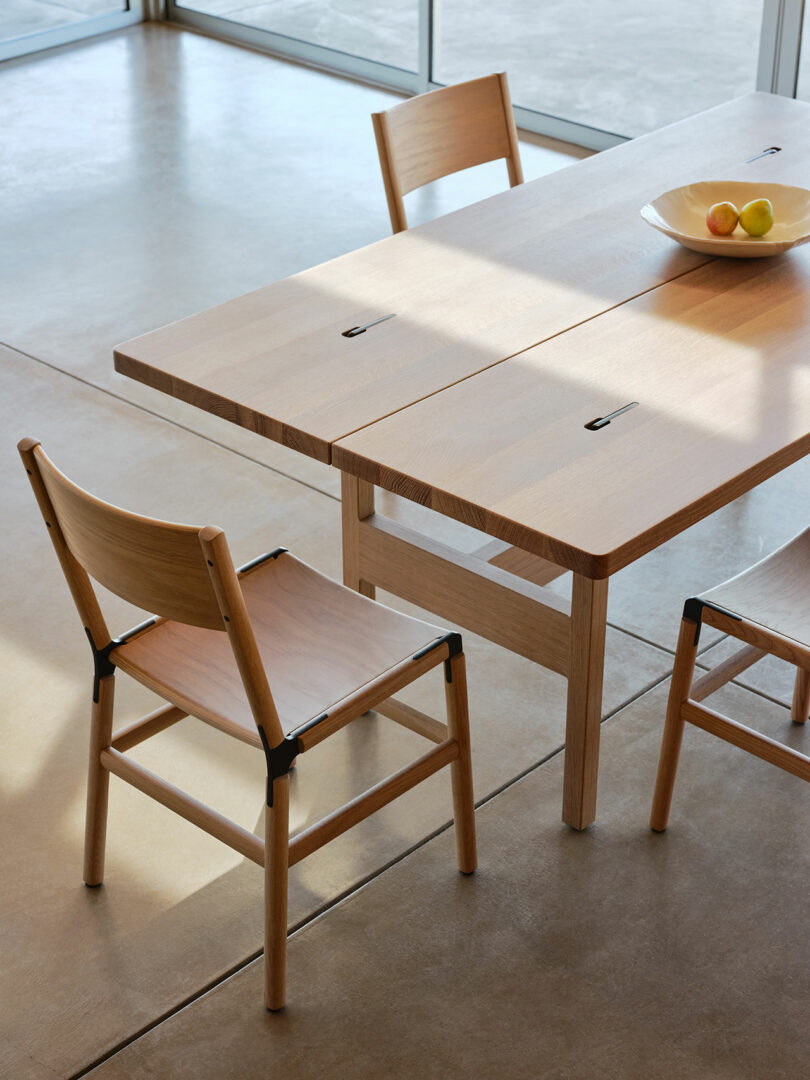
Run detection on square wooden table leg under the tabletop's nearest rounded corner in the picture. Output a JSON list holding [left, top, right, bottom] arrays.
[[563, 573, 608, 828]]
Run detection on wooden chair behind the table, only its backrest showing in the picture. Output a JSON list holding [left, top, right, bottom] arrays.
[[372, 72, 523, 232]]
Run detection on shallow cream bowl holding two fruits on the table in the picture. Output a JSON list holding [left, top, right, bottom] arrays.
[[642, 180, 810, 259]]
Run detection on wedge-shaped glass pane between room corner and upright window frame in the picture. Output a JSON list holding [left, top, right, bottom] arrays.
[[177, 0, 419, 71]]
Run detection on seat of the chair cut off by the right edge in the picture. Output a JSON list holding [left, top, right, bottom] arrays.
[[700, 529, 810, 646]]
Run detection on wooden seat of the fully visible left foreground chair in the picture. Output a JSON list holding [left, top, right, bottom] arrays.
[[110, 552, 445, 746]]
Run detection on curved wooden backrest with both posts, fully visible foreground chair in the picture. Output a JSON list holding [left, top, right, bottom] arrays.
[[17, 438, 283, 745]]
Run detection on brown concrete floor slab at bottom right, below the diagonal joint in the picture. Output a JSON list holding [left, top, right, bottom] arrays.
[[90, 687, 810, 1080]]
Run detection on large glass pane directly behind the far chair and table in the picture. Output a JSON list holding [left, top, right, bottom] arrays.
[[433, 0, 762, 136]]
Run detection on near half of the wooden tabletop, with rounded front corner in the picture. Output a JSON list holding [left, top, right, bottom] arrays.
[[334, 247, 810, 578]]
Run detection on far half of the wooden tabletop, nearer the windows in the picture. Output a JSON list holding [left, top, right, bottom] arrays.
[[116, 94, 810, 461]]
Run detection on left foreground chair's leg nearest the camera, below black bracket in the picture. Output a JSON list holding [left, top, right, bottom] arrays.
[[265, 774, 289, 1012]]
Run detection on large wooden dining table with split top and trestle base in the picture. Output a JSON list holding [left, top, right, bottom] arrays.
[[114, 93, 810, 828]]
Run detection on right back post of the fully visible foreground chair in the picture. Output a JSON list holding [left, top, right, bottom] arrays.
[[199, 525, 284, 748]]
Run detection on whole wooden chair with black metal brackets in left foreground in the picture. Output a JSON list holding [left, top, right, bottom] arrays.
[[18, 438, 476, 1010]]
